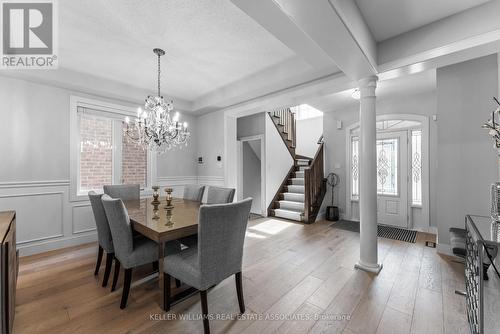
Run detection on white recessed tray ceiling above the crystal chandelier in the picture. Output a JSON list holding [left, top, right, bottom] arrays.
[[59, 0, 295, 101]]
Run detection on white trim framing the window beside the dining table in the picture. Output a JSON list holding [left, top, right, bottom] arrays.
[[69, 95, 156, 202]]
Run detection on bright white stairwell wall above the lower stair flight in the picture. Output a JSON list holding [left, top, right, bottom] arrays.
[[295, 116, 323, 158]]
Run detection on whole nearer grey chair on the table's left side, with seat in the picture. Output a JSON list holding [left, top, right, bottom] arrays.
[[101, 195, 181, 309]]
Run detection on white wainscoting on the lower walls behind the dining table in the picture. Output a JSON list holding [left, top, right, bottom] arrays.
[[0, 176, 224, 256]]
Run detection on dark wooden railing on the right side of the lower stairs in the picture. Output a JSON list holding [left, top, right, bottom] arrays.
[[304, 140, 325, 223]]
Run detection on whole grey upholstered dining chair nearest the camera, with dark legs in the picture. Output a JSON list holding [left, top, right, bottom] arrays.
[[163, 198, 252, 333]]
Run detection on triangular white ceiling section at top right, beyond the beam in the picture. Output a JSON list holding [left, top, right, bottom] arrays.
[[355, 0, 490, 41]]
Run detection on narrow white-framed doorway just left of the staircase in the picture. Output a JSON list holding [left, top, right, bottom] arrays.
[[237, 136, 267, 216]]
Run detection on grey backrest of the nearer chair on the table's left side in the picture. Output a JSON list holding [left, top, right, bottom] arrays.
[[101, 195, 134, 262]]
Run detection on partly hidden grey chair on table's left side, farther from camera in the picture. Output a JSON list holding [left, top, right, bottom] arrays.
[[88, 191, 115, 287]]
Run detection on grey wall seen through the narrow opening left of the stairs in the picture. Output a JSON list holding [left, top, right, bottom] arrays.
[[242, 139, 262, 215]]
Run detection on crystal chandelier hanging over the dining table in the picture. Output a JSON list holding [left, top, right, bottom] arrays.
[[124, 49, 190, 153]]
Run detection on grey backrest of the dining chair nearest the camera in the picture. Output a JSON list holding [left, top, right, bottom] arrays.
[[198, 198, 252, 289]]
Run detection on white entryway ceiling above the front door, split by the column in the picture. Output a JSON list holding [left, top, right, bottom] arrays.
[[304, 70, 436, 112]]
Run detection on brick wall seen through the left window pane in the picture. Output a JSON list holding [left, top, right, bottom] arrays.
[[80, 115, 113, 191]]
